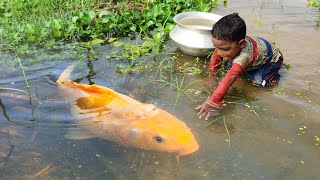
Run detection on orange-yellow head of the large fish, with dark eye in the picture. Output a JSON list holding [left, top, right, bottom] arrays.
[[120, 108, 199, 156]]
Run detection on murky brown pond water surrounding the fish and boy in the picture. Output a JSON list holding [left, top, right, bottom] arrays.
[[0, 0, 320, 179]]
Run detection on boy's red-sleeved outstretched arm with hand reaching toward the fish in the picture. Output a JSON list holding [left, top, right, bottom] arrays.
[[196, 63, 244, 120]]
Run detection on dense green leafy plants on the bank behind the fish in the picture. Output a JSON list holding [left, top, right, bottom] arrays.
[[0, 0, 222, 50]]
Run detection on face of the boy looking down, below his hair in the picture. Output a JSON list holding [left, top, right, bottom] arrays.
[[212, 38, 246, 60]]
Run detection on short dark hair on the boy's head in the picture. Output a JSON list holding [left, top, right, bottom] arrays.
[[211, 13, 247, 41]]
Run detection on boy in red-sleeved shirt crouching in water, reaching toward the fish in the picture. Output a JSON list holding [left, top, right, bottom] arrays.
[[196, 13, 283, 120]]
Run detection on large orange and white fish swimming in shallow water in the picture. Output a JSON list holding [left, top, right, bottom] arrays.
[[57, 65, 199, 155]]
